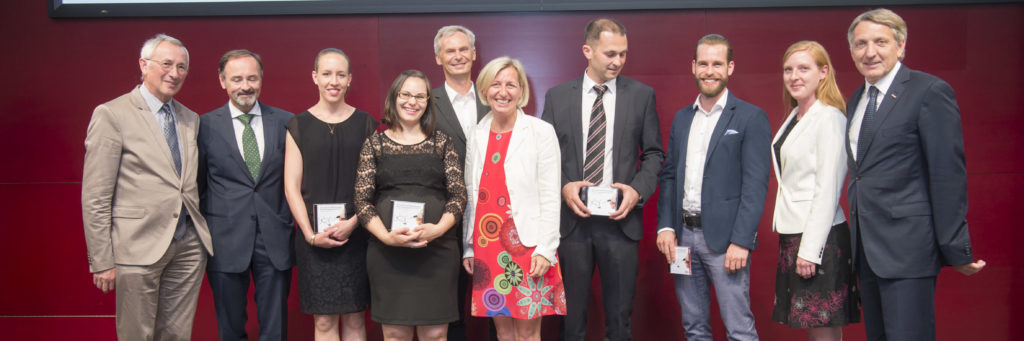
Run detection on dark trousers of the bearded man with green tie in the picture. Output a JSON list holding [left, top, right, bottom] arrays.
[[207, 233, 292, 341]]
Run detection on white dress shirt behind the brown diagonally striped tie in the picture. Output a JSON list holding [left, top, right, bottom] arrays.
[[582, 72, 618, 186]]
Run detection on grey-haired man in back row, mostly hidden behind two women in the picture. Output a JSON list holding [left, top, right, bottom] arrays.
[[430, 25, 497, 341]]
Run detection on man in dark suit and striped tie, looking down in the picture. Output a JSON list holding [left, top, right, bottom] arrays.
[[542, 18, 665, 340]]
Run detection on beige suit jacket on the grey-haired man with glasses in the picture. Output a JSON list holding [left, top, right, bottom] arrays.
[[82, 88, 213, 272]]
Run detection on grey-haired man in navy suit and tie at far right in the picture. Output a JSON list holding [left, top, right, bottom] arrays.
[[847, 9, 985, 340]]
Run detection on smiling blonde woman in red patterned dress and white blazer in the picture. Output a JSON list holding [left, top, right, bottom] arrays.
[[463, 56, 565, 340]]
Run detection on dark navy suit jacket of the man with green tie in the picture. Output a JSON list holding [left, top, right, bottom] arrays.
[[199, 102, 295, 272]]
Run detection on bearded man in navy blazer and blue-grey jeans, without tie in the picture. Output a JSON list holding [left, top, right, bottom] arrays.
[[657, 34, 771, 341]]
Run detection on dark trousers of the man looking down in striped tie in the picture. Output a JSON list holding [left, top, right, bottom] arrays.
[[558, 217, 639, 341]]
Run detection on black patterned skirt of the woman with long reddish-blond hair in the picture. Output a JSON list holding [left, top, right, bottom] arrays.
[[772, 221, 860, 329]]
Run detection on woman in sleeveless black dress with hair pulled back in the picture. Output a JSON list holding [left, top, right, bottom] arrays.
[[285, 48, 378, 340]]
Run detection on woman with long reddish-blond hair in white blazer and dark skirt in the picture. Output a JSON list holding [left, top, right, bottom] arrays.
[[772, 41, 860, 340]]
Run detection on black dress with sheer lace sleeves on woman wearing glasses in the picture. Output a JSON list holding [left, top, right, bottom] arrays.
[[355, 131, 466, 326]]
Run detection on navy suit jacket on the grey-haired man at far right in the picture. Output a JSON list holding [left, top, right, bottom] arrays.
[[846, 66, 974, 279]]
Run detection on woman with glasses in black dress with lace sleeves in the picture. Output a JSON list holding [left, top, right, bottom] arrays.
[[355, 70, 466, 341]]
